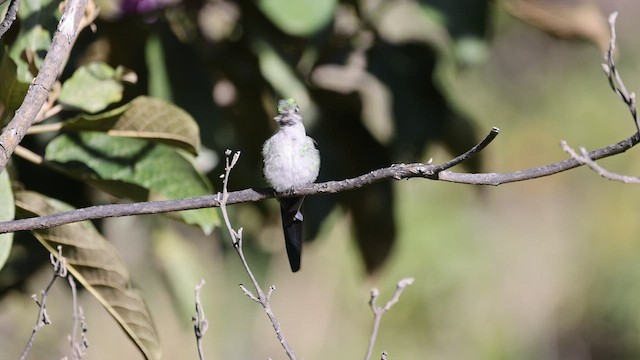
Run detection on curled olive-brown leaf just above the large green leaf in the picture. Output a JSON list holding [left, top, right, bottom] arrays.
[[63, 96, 200, 155]]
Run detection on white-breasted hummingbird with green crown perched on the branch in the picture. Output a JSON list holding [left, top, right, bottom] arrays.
[[262, 99, 320, 272]]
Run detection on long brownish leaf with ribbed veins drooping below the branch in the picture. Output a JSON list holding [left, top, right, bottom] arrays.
[[16, 191, 161, 359]]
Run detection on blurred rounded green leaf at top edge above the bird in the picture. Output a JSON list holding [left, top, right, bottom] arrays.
[[258, 0, 337, 36]]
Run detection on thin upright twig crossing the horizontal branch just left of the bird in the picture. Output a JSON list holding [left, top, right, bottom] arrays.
[[218, 150, 296, 360]]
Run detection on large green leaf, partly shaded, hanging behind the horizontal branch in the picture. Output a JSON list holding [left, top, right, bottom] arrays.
[[45, 132, 218, 234]]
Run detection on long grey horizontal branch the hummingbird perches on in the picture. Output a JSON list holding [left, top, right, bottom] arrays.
[[0, 128, 640, 234]]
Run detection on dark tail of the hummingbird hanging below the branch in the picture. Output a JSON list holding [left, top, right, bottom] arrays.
[[280, 197, 304, 272]]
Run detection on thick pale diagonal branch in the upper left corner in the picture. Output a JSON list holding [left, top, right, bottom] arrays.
[[0, 0, 88, 172]]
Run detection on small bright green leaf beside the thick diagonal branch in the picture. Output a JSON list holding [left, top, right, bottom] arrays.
[[58, 61, 124, 113]]
